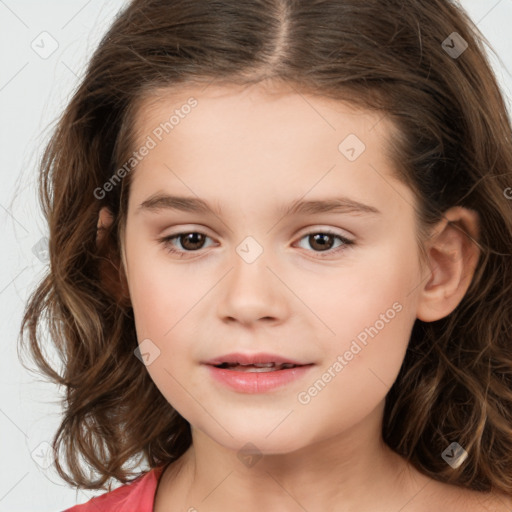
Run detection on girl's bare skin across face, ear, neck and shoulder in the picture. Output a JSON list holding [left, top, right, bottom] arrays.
[[95, 83, 506, 512]]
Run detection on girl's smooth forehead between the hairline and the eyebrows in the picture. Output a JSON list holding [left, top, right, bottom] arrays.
[[127, 84, 413, 220]]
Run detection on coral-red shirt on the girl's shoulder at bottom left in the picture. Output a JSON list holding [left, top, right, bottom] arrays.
[[64, 465, 166, 512]]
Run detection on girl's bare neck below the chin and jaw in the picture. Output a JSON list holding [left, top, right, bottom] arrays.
[[159, 406, 426, 512]]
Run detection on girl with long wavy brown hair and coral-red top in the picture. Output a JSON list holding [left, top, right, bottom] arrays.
[[20, 0, 512, 512]]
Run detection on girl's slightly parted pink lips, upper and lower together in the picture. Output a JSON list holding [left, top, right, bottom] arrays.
[[203, 352, 314, 394]]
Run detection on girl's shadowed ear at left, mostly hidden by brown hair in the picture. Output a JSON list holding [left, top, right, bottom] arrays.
[[96, 206, 131, 306]]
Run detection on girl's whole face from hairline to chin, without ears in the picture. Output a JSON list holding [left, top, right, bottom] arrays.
[[124, 84, 426, 453]]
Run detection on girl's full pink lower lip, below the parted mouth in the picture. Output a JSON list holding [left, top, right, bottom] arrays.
[[203, 364, 313, 393]]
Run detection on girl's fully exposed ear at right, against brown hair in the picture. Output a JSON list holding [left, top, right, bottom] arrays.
[[416, 206, 480, 322]]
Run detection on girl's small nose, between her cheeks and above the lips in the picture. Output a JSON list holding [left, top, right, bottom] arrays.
[[217, 246, 290, 326]]
